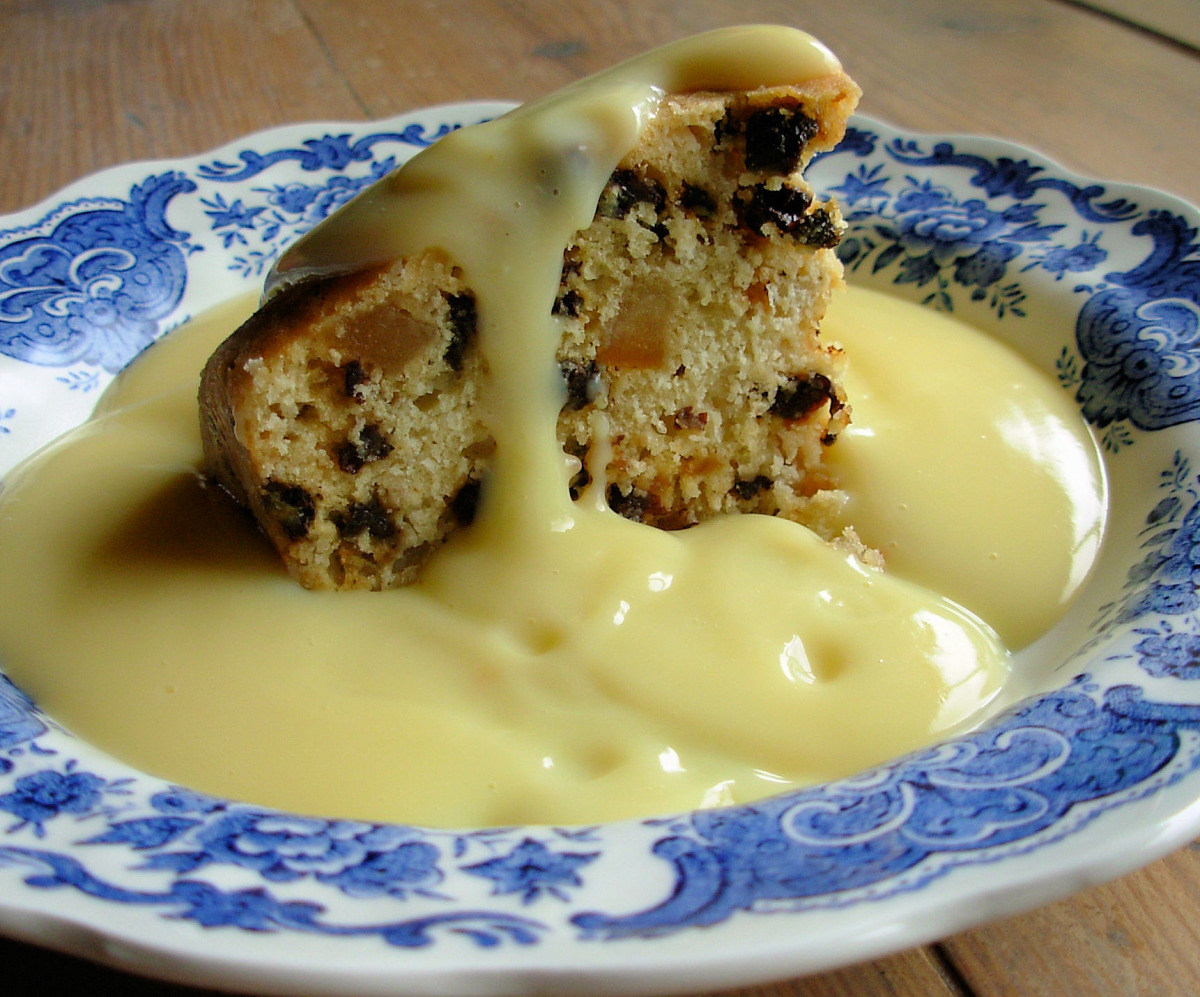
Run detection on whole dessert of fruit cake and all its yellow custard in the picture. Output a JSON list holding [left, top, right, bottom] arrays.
[[0, 28, 1104, 828]]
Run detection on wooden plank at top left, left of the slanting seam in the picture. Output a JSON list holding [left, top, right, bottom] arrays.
[[0, 0, 362, 211]]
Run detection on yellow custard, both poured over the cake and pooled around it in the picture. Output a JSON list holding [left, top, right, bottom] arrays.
[[0, 28, 1103, 827]]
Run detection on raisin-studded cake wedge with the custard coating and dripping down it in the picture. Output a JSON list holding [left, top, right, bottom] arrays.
[[200, 28, 859, 589]]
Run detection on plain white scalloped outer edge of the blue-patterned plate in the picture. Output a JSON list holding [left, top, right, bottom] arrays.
[[0, 101, 1200, 993]]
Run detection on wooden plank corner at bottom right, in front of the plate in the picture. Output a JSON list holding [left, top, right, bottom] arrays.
[[944, 843, 1200, 997]]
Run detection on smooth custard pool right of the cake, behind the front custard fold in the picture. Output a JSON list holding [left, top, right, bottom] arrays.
[[823, 289, 1108, 649]]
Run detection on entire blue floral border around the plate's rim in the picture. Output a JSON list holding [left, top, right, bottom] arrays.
[[0, 110, 1200, 974]]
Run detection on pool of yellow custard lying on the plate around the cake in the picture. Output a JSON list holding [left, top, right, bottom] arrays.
[[0, 288, 1104, 825]]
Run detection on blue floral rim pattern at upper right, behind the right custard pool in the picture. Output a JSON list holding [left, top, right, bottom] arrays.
[[816, 127, 1200, 451]]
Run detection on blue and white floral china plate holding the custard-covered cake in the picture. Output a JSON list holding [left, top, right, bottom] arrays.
[[0, 104, 1200, 995]]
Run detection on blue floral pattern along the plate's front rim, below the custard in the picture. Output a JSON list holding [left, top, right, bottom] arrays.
[[7, 659, 1200, 948]]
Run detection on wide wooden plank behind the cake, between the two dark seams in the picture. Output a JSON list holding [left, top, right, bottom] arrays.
[[298, 0, 1200, 202]]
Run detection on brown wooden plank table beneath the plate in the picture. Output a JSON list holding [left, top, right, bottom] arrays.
[[0, 0, 1200, 997]]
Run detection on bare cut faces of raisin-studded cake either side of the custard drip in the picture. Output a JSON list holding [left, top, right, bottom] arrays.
[[200, 76, 858, 589]]
